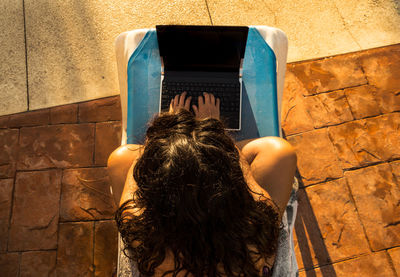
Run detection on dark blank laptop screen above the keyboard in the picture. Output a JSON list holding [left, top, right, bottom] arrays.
[[156, 25, 249, 72]]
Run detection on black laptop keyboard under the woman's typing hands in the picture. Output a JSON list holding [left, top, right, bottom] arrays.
[[161, 80, 240, 129]]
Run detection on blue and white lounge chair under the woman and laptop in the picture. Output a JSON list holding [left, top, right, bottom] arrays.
[[115, 26, 297, 276]]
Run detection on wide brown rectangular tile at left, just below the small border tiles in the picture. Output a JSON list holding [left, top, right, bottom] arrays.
[[17, 124, 94, 170]]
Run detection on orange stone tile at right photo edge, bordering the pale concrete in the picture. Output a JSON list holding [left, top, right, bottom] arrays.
[[361, 45, 400, 113]]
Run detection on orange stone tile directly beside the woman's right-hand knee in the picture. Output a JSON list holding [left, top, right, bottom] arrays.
[[287, 129, 343, 185]]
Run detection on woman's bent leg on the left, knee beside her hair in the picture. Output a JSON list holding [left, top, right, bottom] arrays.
[[107, 144, 142, 207]]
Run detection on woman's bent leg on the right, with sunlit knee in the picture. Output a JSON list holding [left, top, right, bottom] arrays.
[[236, 137, 297, 215]]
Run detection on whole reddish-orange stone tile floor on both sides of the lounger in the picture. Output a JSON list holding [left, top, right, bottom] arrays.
[[0, 45, 400, 276]]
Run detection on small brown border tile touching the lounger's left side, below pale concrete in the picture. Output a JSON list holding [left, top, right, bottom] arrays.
[[79, 95, 122, 122]]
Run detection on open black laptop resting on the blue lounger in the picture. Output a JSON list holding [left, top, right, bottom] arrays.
[[156, 25, 248, 131]]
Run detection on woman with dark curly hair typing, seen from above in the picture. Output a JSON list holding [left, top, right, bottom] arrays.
[[108, 93, 296, 276]]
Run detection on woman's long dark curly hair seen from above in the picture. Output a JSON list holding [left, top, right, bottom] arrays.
[[116, 110, 279, 276]]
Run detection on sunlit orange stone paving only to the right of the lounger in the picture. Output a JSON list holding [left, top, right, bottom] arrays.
[[283, 45, 400, 276]]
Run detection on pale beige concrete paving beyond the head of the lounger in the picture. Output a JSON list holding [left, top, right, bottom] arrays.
[[0, 0, 400, 115]]
